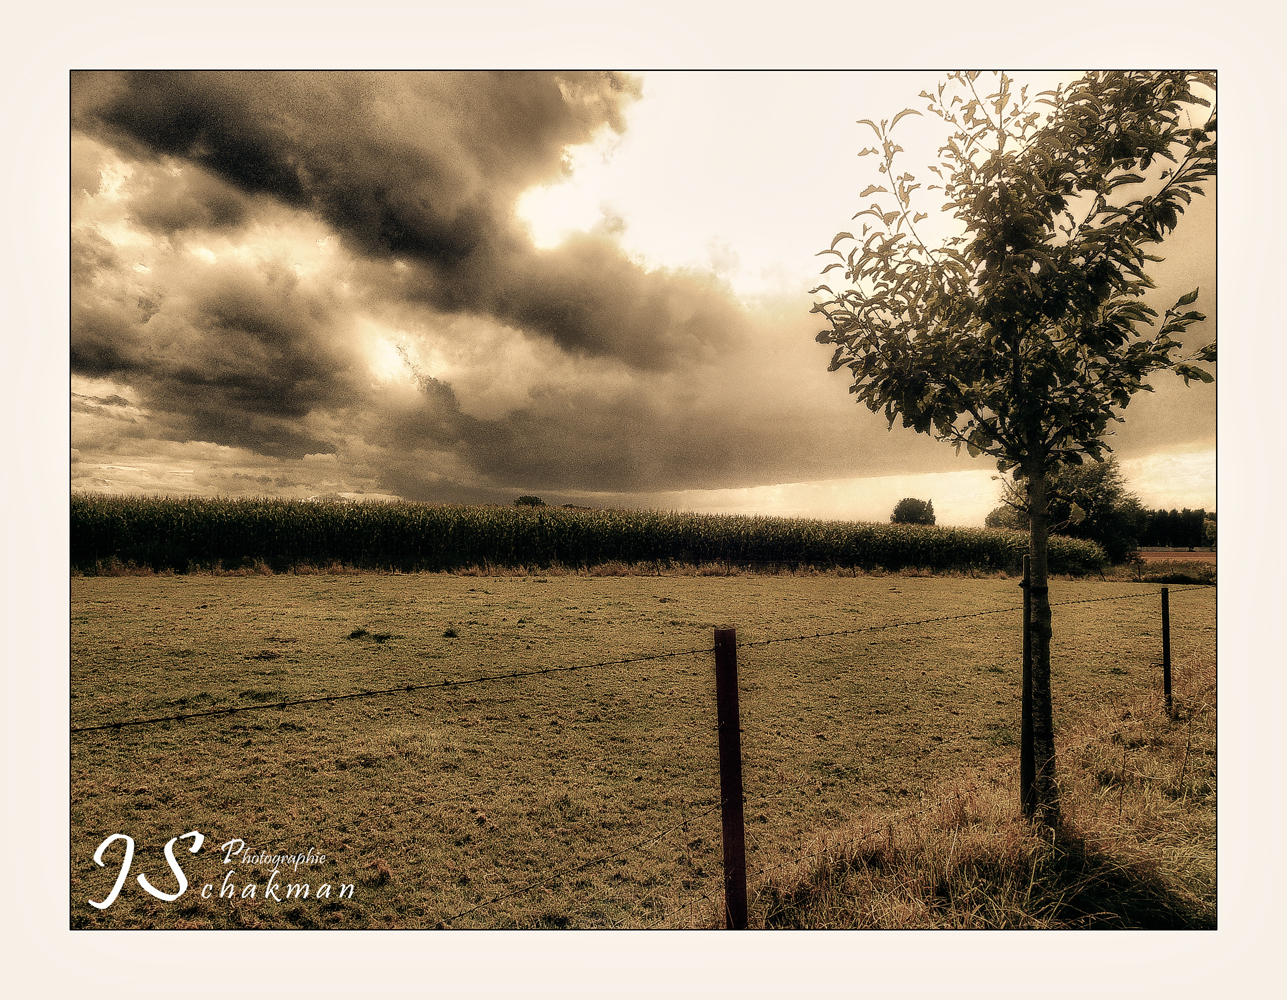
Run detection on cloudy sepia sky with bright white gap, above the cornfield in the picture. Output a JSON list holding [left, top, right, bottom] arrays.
[[69, 72, 1216, 525]]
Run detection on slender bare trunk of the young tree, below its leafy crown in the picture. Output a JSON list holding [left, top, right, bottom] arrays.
[[1023, 462, 1059, 826]]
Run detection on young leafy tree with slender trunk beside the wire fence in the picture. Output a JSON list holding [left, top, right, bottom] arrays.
[[813, 72, 1216, 824]]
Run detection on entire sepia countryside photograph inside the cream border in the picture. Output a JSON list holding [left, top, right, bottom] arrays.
[[69, 71, 1218, 931]]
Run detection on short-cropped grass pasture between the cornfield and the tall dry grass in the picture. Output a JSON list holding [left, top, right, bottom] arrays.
[[69, 574, 1215, 928]]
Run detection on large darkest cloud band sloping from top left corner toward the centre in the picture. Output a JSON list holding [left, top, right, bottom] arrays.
[[73, 72, 737, 368]]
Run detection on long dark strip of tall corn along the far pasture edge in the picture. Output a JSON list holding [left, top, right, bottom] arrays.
[[71, 494, 1107, 575]]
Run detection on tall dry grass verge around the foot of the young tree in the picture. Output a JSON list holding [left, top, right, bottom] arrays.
[[750, 659, 1216, 929]]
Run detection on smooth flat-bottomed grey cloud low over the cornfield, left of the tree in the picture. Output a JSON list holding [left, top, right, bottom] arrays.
[[432, 328, 957, 492]]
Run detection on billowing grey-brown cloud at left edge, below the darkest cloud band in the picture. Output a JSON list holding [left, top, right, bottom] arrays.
[[71, 225, 368, 458]]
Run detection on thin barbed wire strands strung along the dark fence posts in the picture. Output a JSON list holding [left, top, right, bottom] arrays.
[[69, 587, 1210, 928]]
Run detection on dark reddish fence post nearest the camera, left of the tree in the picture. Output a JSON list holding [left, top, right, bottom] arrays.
[[716, 628, 746, 931]]
